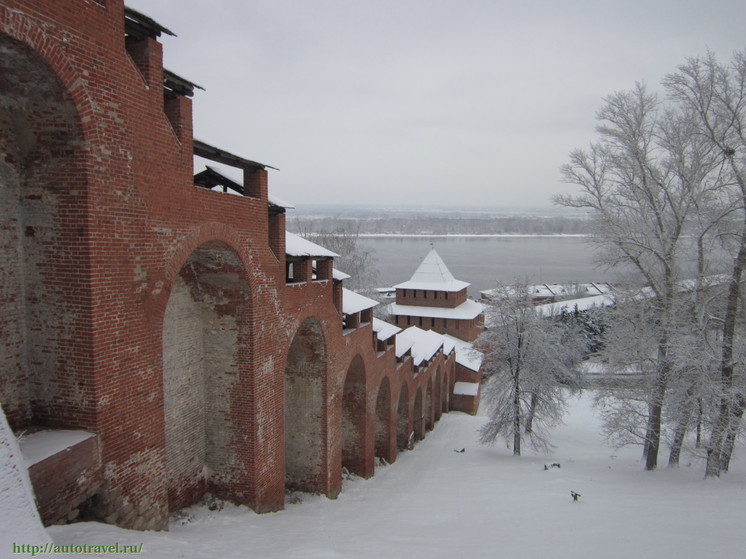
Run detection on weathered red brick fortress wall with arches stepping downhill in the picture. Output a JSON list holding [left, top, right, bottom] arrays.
[[0, 0, 454, 529]]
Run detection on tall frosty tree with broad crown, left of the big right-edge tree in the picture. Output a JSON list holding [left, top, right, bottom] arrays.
[[555, 84, 719, 470]]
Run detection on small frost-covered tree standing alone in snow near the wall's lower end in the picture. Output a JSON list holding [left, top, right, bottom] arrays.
[[476, 285, 586, 456]]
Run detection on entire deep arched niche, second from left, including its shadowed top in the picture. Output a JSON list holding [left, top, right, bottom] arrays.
[[161, 240, 253, 509]]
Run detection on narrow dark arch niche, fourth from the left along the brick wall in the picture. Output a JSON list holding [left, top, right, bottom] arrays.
[[341, 355, 372, 477]]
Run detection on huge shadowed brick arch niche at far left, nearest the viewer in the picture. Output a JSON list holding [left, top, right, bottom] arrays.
[[0, 28, 96, 436]]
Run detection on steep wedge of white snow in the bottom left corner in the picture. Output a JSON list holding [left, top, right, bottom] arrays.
[[0, 407, 52, 553]]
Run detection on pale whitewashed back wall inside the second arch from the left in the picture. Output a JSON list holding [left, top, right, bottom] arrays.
[[163, 260, 241, 496]]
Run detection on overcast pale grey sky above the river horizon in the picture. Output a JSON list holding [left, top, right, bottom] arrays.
[[127, 0, 746, 210]]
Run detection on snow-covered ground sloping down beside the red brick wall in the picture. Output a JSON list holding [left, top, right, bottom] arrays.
[[49, 394, 746, 559]]
